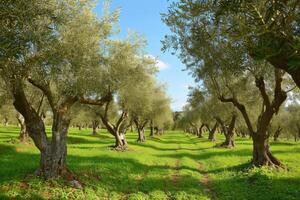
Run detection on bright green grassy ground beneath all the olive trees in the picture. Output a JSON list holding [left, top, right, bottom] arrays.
[[0, 128, 300, 200]]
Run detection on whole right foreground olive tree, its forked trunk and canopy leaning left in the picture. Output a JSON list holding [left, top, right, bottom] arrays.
[[164, 1, 296, 167]]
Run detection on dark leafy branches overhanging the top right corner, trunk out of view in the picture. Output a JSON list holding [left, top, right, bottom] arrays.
[[163, 0, 300, 87]]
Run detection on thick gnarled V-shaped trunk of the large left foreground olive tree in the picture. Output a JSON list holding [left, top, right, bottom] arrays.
[[12, 80, 76, 179]]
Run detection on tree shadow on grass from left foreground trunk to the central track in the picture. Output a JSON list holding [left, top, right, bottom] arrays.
[[68, 153, 209, 195]]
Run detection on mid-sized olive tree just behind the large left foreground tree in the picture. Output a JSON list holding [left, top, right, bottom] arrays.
[[85, 35, 156, 150]]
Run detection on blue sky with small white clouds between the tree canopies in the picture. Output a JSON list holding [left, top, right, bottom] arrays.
[[95, 0, 193, 110]]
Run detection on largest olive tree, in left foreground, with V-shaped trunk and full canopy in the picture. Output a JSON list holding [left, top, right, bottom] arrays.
[[0, 0, 117, 178]]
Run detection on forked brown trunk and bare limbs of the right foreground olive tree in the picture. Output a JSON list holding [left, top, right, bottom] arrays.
[[219, 69, 287, 167]]
